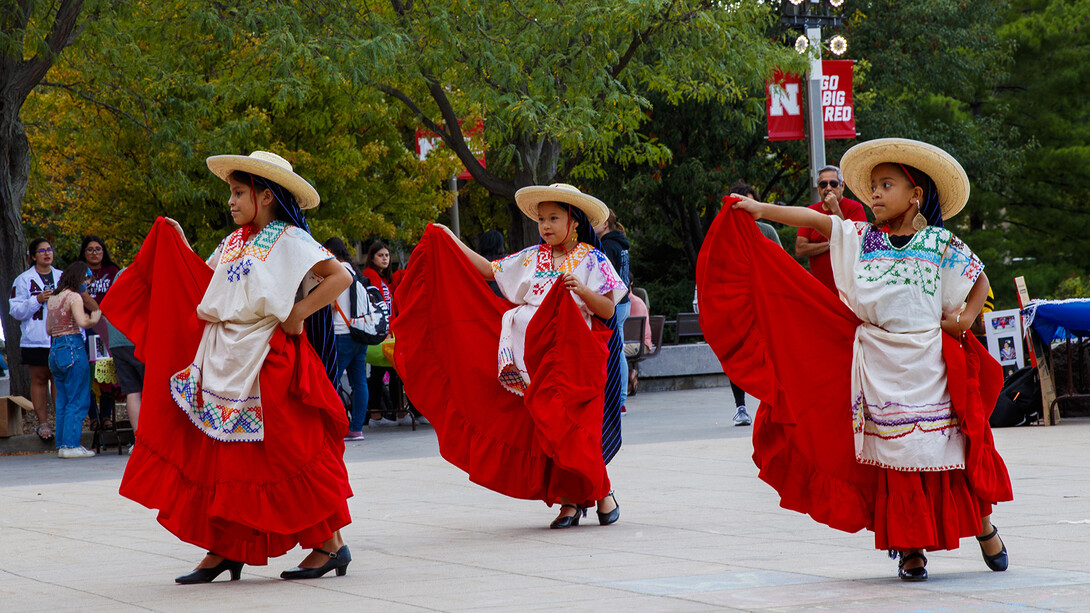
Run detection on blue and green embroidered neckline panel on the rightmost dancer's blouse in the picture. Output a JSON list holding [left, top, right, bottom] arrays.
[[857, 227, 953, 296]]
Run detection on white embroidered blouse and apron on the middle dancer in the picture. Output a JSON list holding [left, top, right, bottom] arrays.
[[492, 242, 628, 396]]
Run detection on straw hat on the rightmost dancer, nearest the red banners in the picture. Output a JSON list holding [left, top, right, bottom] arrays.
[[840, 139, 969, 219]]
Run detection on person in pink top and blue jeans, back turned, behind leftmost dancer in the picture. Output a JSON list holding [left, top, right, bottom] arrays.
[[46, 262, 102, 458]]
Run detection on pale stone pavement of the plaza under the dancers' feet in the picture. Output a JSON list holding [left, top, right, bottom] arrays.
[[0, 388, 1090, 613]]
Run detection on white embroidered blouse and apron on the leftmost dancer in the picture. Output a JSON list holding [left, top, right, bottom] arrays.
[[170, 220, 332, 441]]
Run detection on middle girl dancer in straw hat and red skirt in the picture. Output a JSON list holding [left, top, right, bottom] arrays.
[[393, 183, 627, 528]]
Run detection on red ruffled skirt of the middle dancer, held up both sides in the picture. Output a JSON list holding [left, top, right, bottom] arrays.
[[392, 226, 609, 505]]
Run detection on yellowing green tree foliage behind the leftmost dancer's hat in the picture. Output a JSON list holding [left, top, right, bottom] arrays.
[[25, 1, 458, 258]]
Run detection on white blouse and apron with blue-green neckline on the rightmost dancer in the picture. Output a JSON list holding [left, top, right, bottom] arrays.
[[829, 217, 984, 471]]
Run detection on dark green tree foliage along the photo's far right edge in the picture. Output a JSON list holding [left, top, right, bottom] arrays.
[[988, 0, 1090, 304]]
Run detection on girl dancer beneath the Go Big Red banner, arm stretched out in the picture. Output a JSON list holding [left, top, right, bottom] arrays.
[[697, 139, 1012, 581]]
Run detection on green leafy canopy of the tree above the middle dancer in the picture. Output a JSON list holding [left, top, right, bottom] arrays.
[[351, 0, 792, 248]]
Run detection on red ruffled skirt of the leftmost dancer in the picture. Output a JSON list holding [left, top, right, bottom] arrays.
[[102, 218, 352, 565]]
